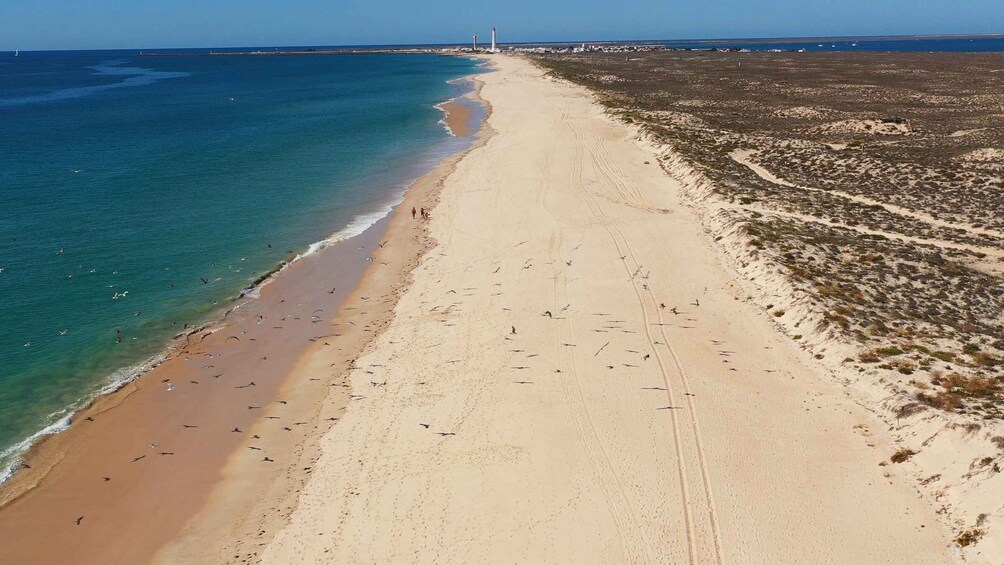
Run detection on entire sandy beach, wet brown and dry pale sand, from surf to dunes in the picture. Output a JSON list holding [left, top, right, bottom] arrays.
[[0, 51, 962, 564]]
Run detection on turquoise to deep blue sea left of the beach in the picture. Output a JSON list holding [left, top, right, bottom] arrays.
[[0, 51, 476, 478]]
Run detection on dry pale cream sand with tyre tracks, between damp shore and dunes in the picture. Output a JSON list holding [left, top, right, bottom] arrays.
[[255, 57, 952, 564]]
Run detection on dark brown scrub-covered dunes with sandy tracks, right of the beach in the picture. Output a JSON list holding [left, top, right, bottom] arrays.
[[536, 52, 1004, 417]]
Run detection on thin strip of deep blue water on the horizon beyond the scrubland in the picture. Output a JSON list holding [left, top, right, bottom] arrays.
[[666, 37, 1004, 52]]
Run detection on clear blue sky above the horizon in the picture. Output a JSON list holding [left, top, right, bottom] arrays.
[[0, 0, 1004, 50]]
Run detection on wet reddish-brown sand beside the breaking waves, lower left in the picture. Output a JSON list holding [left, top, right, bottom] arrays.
[[0, 81, 485, 563]]
